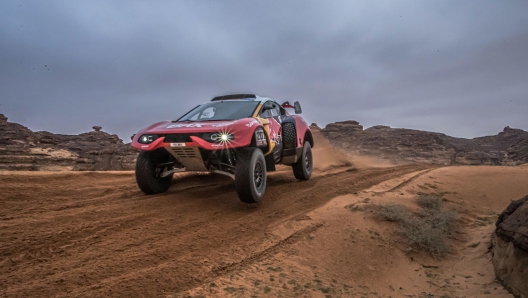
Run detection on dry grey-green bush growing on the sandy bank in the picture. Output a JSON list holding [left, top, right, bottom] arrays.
[[377, 195, 459, 257]]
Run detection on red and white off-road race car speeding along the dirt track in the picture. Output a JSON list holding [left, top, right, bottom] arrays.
[[132, 94, 314, 203]]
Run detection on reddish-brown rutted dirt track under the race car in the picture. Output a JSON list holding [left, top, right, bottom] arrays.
[[0, 166, 425, 297]]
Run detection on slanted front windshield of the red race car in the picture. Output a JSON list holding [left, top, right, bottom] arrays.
[[177, 100, 259, 121]]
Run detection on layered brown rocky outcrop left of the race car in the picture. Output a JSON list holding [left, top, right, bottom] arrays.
[[0, 114, 137, 171]]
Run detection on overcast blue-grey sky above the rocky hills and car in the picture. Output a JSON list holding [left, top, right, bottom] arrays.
[[0, 0, 528, 142]]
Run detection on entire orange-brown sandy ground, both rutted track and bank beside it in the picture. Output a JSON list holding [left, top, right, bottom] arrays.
[[0, 133, 528, 297]]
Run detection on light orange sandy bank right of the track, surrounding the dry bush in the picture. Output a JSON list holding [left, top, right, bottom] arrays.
[[184, 167, 528, 298]]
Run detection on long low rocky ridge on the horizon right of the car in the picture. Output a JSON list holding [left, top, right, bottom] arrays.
[[321, 121, 528, 165]]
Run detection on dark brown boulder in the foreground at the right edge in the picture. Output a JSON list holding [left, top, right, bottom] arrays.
[[492, 196, 528, 298]]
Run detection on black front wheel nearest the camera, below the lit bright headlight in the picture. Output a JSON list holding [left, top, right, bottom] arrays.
[[235, 148, 267, 204]]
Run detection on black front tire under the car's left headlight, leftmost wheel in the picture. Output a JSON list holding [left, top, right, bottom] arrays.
[[136, 148, 172, 195]]
